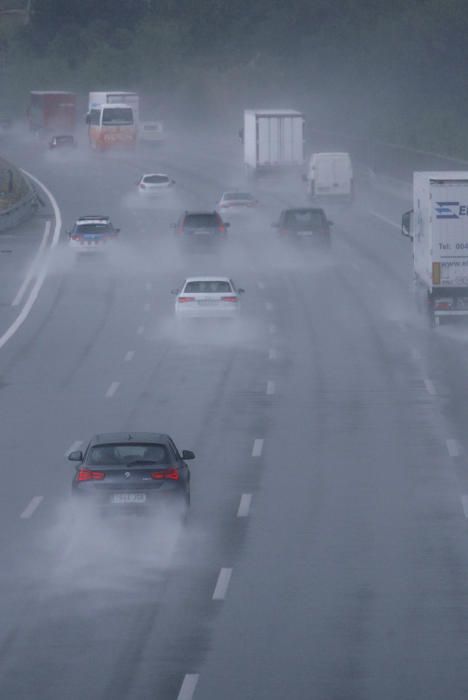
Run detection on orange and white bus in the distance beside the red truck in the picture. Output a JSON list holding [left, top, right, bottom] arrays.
[[86, 103, 138, 151]]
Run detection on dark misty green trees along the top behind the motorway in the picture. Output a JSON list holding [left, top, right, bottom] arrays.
[[2, 0, 468, 155]]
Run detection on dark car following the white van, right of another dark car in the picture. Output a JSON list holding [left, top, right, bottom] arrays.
[[272, 207, 333, 248]]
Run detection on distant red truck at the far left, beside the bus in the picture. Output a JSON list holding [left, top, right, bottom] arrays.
[[28, 90, 76, 133]]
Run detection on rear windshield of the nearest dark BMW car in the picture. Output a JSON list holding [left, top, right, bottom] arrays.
[[86, 442, 170, 467]]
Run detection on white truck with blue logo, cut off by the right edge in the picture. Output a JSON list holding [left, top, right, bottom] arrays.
[[402, 171, 468, 325]]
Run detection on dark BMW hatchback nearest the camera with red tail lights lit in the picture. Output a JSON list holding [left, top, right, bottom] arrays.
[[68, 433, 195, 513]]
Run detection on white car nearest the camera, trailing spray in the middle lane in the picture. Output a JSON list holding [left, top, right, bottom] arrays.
[[173, 277, 244, 318]]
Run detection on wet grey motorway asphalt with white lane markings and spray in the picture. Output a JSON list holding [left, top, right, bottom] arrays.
[[0, 129, 468, 700]]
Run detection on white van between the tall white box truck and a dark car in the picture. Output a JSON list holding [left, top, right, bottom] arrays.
[[304, 153, 353, 201]]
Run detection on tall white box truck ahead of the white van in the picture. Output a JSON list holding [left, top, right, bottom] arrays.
[[243, 109, 304, 175]]
